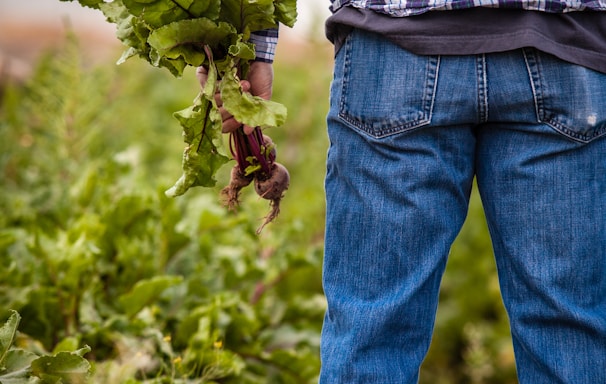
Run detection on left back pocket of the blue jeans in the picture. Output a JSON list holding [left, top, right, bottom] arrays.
[[335, 30, 440, 138]]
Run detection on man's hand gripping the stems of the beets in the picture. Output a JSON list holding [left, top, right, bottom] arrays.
[[196, 61, 274, 135]]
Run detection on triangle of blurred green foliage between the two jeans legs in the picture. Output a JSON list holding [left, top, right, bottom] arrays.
[[421, 189, 517, 384]]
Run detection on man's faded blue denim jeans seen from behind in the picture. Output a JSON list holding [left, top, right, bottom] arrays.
[[320, 30, 606, 384]]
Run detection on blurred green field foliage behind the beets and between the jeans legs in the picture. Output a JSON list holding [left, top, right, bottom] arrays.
[[0, 22, 516, 384]]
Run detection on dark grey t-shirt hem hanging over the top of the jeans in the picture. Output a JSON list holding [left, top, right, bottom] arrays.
[[326, 7, 606, 73]]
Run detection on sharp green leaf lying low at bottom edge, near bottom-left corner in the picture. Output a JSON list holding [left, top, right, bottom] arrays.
[[31, 347, 91, 384]]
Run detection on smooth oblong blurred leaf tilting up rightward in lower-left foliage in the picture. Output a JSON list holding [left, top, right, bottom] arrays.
[[118, 276, 183, 317]]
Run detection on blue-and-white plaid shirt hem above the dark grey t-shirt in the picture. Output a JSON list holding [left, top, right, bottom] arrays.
[[331, 0, 606, 17]]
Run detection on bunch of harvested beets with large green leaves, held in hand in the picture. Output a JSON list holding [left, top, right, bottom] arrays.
[[62, 0, 297, 230]]
